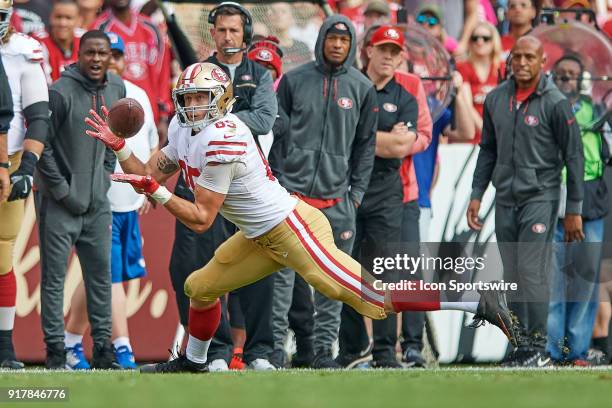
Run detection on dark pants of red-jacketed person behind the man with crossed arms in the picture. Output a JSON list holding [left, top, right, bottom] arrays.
[[402, 200, 425, 351]]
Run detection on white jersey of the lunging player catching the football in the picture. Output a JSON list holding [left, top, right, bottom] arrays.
[[162, 113, 297, 238]]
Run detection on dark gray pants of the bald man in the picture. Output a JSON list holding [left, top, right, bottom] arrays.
[[495, 201, 559, 351]]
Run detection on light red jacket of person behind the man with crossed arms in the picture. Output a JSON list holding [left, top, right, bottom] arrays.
[[395, 72, 433, 203]]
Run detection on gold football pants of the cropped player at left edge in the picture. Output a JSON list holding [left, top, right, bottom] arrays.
[[0, 152, 25, 275]]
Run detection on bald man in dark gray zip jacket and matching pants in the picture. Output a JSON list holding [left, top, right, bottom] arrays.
[[467, 36, 584, 367]]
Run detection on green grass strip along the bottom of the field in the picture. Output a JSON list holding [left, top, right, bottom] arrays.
[[0, 368, 612, 408]]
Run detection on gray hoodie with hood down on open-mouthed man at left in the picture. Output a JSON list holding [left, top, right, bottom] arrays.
[[35, 64, 125, 215]]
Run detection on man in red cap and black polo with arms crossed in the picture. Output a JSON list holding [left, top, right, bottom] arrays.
[[338, 26, 419, 368]]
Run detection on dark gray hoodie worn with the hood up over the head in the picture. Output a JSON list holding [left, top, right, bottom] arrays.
[[275, 15, 378, 203]]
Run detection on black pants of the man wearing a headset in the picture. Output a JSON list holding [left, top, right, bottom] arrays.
[[170, 177, 274, 363]]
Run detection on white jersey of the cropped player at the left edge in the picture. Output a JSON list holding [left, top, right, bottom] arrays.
[[0, 33, 49, 155]]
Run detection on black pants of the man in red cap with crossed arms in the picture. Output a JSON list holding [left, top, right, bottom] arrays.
[[340, 173, 402, 361]]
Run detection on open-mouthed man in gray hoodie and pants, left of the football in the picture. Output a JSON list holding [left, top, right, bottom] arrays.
[[34, 30, 125, 369]]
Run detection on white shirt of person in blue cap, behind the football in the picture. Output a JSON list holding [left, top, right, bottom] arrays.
[[107, 79, 159, 212]]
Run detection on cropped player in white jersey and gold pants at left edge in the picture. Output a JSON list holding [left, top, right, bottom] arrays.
[[0, 0, 49, 368]]
